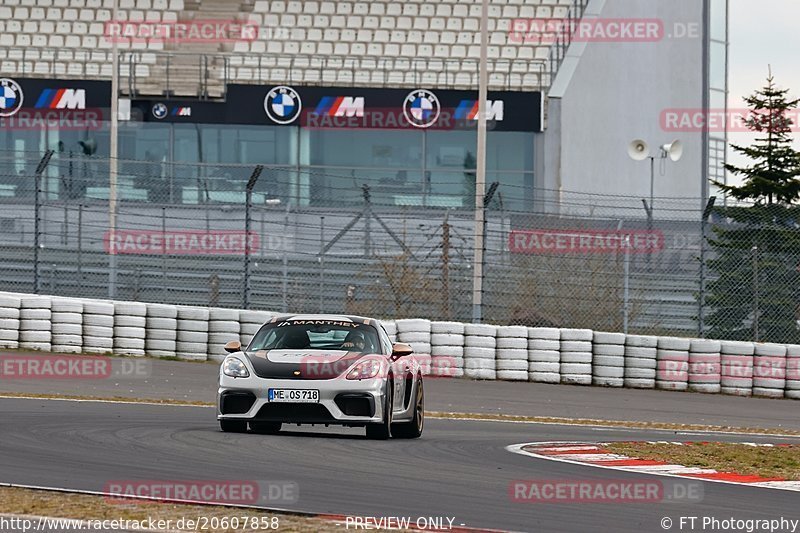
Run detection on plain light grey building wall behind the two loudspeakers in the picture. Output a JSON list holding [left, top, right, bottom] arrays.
[[537, 0, 703, 219]]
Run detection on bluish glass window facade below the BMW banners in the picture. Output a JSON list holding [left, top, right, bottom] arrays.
[[0, 122, 535, 211]]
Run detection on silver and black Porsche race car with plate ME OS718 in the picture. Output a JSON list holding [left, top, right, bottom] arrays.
[[212, 315, 425, 439]]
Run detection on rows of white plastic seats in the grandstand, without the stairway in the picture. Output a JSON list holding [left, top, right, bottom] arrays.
[[0, 0, 556, 88]]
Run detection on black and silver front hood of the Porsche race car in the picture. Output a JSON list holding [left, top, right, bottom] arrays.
[[245, 350, 368, 379]]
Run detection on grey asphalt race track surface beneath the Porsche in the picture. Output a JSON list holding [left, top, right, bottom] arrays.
[[0, 394, 800, 531]]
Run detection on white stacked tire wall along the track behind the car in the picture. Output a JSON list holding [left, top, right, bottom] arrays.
[[0, 292, 800, 399]]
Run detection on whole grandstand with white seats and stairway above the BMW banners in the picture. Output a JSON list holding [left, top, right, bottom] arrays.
[[0, 0, 586, 97]]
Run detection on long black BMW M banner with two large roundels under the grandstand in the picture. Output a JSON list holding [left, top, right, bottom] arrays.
[[132, 84, 543, 132]]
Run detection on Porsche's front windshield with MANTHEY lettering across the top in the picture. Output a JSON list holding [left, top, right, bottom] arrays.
[[247, 320, 380, 353]]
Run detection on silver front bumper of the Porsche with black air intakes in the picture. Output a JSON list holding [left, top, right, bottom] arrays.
[[217, 373, 386, 425]]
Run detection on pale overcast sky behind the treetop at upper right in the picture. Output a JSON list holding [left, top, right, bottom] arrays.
[[728, 0, 800, 172]]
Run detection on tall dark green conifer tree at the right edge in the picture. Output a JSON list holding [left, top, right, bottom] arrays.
[[706, 73, 800, 342]]
